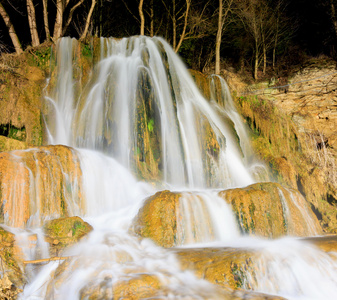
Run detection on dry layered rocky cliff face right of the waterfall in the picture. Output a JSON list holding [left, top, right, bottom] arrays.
[[224, 59, 337, 232]]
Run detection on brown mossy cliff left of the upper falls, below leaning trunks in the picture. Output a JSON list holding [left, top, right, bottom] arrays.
[[0, 50, 50, 151]]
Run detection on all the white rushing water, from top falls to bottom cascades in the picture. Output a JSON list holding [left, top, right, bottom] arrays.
[[9, 37, 337, 299]]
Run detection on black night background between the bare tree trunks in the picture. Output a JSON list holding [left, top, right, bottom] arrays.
[[0, 0, 337, 77]]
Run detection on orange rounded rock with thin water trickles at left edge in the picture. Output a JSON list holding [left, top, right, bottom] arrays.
[[0, 146, 82, 227]]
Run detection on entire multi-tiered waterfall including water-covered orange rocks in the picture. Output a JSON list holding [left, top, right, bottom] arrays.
[[0, 36, 337, 299]]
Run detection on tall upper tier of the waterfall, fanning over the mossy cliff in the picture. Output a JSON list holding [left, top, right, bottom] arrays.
[[47, 37, 254, 188]]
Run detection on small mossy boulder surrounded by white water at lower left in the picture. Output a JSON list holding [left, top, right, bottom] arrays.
[[43, 216, 93, 256]]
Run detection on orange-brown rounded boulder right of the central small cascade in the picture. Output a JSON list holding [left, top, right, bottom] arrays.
[[219, 182, 321, 238]]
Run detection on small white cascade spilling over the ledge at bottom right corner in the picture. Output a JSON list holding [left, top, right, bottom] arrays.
[[244, 239, 337, 300]]
